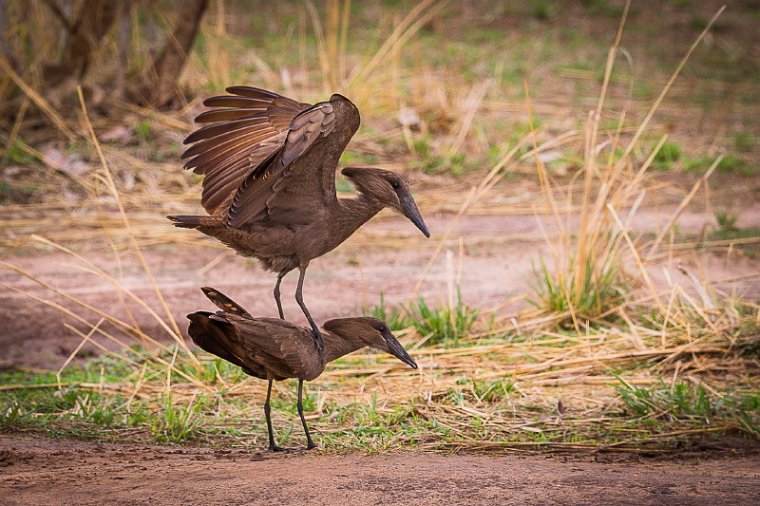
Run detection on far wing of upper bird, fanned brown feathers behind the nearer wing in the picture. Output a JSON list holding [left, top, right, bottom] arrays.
[[182, 86, 309, 214]]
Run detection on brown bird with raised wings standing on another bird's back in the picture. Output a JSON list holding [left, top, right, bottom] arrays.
[[169, 86, 430, 348]]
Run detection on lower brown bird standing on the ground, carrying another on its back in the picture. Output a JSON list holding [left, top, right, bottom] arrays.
[[187, 287, 417, 451]]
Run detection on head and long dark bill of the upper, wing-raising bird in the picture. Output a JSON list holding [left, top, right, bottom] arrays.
[[341, 167, 430, 237]]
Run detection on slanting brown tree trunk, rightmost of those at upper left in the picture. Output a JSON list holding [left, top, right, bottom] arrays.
[[146, 0, 208, 107]]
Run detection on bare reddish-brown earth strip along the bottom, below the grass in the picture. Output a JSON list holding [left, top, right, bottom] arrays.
[[0, 436, 760, 506]]
